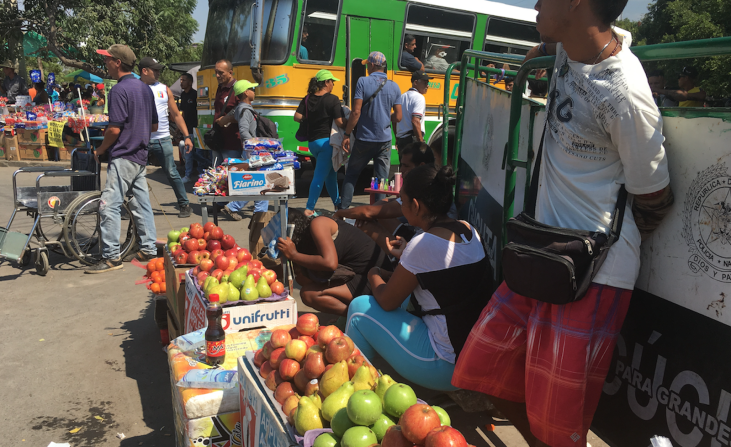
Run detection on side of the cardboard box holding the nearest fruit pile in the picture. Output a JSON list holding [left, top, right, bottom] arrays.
[[238, 357, 298, 447]]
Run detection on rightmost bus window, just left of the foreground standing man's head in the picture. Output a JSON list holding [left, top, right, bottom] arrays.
[[483, 17, 541, 68]]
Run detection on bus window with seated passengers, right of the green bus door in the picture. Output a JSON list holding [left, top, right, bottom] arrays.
[[399, 3, 475, 73]]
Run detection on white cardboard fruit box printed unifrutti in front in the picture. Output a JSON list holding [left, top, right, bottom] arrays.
[[186, 274, 297, 334]]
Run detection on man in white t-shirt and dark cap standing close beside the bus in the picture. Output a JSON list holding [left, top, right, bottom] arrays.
[[391, 71, 430, 158]]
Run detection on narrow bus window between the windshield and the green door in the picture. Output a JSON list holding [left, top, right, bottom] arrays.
[[297, 0, 340, 64]]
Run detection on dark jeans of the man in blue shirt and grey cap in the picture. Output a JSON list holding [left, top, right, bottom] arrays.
[[341, 140, 391, 208]]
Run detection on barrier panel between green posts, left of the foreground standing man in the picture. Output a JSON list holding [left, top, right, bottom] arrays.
[[457, 78, 543, 285]]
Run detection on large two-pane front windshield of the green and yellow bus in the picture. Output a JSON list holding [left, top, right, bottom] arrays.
[[201, 0, 295, 68]]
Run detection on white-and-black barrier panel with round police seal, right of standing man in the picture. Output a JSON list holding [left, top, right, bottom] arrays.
[[594, 113, 731, 447]]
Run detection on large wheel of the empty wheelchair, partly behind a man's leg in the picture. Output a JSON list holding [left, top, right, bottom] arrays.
[[64, 191, 137, 265]]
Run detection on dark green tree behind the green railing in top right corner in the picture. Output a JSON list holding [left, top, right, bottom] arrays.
[[636, 0, 731, 98]]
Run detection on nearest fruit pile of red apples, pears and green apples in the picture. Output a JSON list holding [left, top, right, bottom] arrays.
[[254, 314, 468, 447]]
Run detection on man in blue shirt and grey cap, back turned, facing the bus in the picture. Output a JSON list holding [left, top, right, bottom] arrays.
[[341, 51, 401, 209]]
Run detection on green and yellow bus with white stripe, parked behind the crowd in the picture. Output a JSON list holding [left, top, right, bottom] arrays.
[[198, 0, 539, 163]]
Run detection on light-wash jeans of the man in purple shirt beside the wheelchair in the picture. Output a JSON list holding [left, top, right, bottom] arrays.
[[99, 158, 157, 259]]
